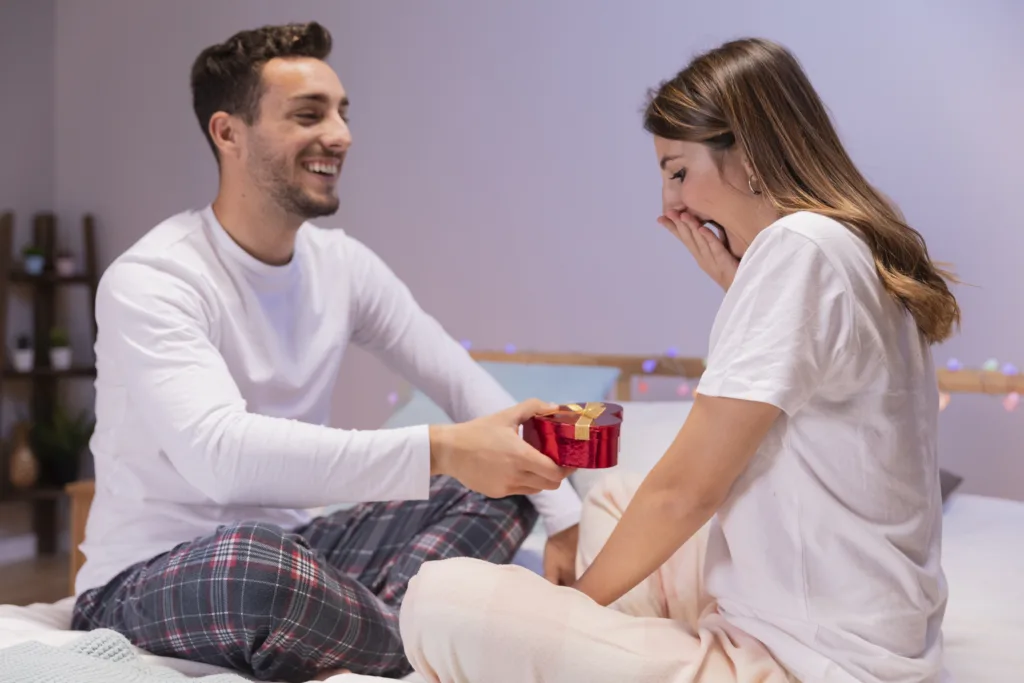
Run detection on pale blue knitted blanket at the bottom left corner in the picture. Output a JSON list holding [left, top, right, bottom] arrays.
[[0, 629, 250, 683]]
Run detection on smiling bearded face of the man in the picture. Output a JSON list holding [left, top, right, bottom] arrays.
[[243, 57, 352, 220]]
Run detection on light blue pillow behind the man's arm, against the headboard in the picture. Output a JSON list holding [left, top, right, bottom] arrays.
[[382, 361, 621, 429]]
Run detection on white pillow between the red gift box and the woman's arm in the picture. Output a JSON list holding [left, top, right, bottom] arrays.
[[569, 400, 693, 498]]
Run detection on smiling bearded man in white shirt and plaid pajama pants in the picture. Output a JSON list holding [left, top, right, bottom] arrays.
[[74, 24, 580, 680]]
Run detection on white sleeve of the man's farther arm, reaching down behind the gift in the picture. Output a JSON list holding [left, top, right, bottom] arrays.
[[346, 238, 581, 536]]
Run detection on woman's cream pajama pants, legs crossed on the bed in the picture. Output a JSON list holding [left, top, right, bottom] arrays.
[[400, 475, 793, 683]]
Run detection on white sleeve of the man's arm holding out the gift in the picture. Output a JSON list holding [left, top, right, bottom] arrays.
[[103, 262, 431, 508]]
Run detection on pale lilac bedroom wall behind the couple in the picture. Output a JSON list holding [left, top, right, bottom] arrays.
[[48, 0, 1024, 499]]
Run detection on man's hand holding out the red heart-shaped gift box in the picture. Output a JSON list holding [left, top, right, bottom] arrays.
[[430, 398, 571, 498]]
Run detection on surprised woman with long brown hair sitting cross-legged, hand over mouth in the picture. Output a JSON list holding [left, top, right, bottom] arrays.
[[401, 40, 959, 683]]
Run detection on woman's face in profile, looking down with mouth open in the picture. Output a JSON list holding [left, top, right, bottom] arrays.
[[654, 136, 770, 258]]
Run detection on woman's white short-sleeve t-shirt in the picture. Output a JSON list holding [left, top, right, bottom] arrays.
[[697, 212, 947, 683]]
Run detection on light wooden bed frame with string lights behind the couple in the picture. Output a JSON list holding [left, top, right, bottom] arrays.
[[61, 351, 1024, 592]]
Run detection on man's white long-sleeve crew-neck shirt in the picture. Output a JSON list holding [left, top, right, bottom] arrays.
[[76, 207, 581, 593]]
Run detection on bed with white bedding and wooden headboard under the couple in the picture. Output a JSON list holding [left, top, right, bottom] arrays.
[[0, 351, 1024, 683]]
